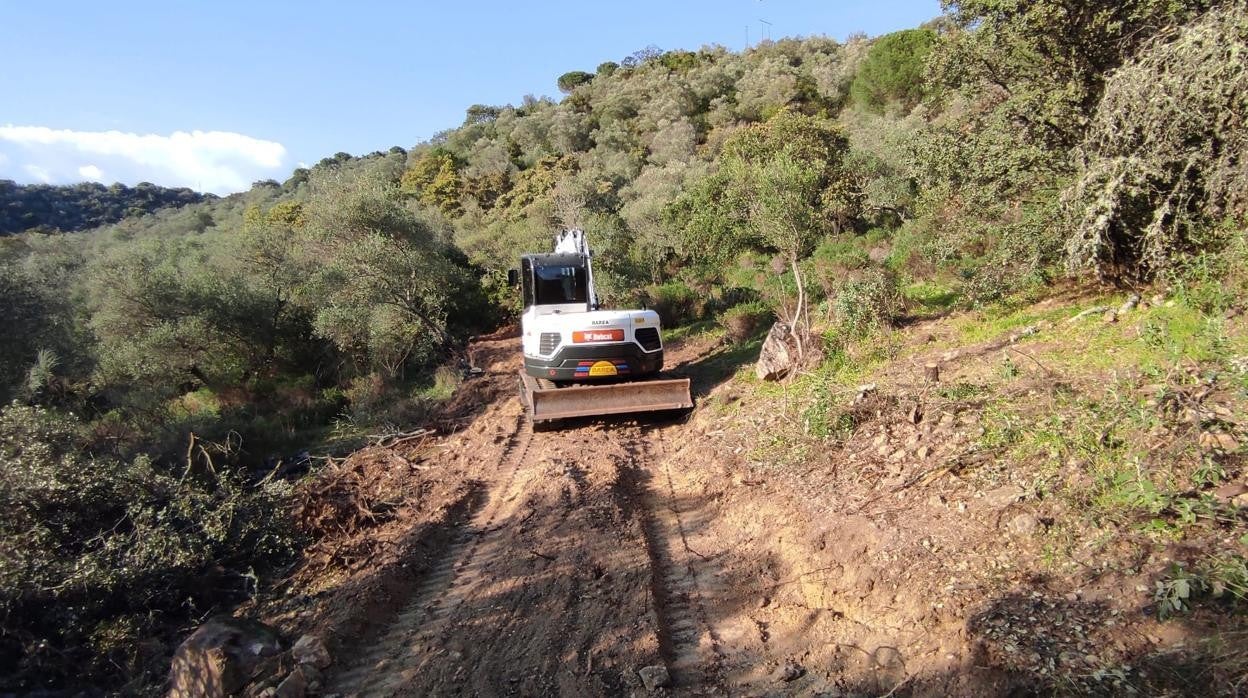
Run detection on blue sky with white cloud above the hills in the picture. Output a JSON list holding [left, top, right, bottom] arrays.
[[0, 0, 940, 194]]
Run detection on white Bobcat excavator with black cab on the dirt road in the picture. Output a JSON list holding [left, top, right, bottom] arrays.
[[508, 230, 694, 425]]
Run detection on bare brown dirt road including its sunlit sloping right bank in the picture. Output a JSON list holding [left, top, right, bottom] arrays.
[[312, 337, 1002, 697]]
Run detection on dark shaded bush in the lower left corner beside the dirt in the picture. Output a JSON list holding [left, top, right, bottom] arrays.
[[0, 405, 295, 693]]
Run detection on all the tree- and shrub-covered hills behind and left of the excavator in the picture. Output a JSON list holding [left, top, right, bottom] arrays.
[[0, 0, 1248, 691]]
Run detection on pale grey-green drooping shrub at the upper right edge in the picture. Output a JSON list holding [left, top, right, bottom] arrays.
[[1065, 2, 1248, 278]]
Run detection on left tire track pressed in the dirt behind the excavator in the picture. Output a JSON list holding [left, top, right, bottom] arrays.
[[328, 415, 533, 697]]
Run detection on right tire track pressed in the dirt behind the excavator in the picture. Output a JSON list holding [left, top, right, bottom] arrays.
[[628, 428, 725, 689]]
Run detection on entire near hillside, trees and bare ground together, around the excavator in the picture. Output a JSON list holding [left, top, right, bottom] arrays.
[[0, 0, 1248, 696]]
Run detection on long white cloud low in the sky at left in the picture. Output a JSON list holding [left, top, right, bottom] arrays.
[[0, 124, 286, 194]]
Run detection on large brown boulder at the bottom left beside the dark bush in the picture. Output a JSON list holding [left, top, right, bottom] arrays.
[[167, 617, 282, 698]]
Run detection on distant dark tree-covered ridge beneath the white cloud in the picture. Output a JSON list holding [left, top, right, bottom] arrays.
[[0, 180, 212, 235]]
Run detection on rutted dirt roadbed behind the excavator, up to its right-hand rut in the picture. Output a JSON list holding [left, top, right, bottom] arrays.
[[328, 340, 721, 696]]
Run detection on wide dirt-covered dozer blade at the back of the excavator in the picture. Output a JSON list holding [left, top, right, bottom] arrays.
[[520, 370, 694, 422]]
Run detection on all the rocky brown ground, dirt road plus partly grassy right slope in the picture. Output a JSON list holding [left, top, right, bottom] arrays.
[[178, 288, 1248, 696]]
